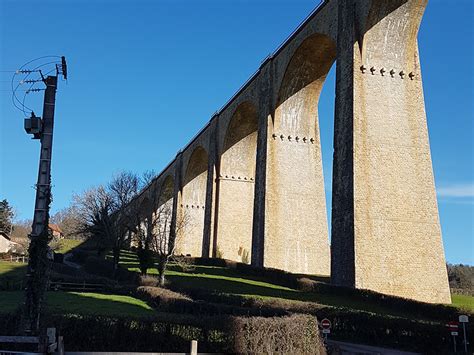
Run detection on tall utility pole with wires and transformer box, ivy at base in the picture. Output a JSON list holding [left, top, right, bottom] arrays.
[[23, 57, 67, 334]]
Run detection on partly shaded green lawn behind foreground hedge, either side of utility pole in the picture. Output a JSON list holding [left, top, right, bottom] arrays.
[[0, 291, 155, 318]]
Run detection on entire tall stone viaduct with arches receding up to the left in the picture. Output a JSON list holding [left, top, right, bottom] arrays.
[[129, 0, 450, 303]]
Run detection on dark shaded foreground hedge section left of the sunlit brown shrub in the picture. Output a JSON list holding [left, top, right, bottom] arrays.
[[0, 313, 230, 353]]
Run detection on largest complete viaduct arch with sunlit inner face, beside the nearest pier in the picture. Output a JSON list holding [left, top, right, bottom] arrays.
[[264, 34, 336, 275]]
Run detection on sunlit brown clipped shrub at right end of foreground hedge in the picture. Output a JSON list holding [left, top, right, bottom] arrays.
[[232, 314, 326, 354]]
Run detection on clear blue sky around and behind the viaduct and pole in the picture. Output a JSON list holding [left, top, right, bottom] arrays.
[[0, 0, 474, 264]]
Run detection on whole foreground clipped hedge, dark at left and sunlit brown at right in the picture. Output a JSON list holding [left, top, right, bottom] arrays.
[[0, 313, 324, 354]]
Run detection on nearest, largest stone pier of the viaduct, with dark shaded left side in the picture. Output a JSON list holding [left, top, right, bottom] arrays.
[[332, 0, 451, 303]]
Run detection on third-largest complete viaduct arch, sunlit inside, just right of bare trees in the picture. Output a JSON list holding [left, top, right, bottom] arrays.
[[176, 146, 208, 256]]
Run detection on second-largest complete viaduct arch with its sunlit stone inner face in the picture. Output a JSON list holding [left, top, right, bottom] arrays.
[[214, 102, 258, 262]]
